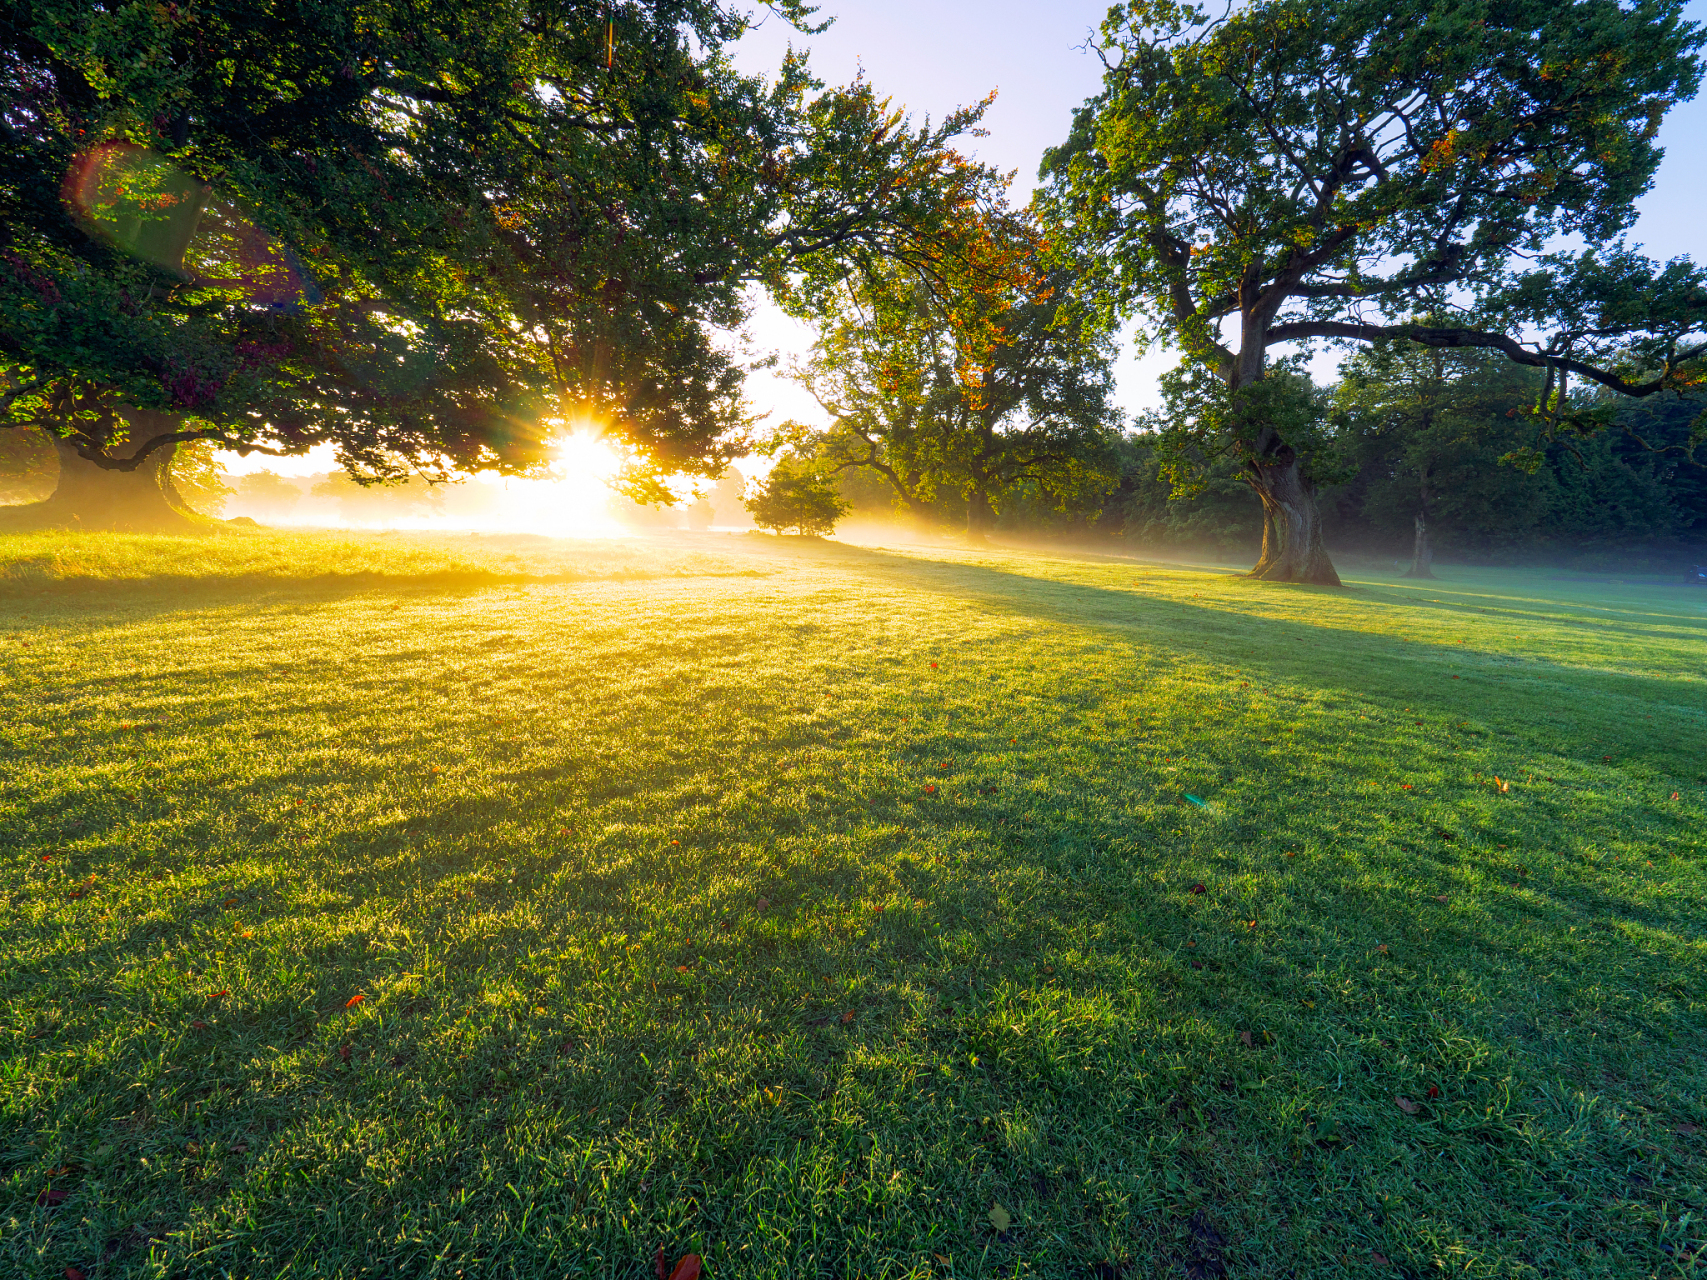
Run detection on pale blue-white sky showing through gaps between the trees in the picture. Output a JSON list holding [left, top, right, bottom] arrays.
[[230, 0, 1707, 474]]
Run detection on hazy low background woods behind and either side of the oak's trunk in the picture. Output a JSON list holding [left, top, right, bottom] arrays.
[[801, 348, 1707, 568]]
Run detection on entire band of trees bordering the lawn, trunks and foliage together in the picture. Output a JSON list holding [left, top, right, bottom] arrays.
[[0, 0, 1707, 585]]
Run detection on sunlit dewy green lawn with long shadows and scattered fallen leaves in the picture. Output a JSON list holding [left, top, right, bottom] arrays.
[[0, 534, 1707, 1278]]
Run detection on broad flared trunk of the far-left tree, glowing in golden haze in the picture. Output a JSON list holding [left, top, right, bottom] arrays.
[[18, 410, 198, 532]]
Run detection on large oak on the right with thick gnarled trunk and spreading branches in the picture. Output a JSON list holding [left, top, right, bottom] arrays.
[[1045, 0, 1707, 584]]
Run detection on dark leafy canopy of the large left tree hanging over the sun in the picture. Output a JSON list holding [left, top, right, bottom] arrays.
[[0, 0, 1000, 495]]
